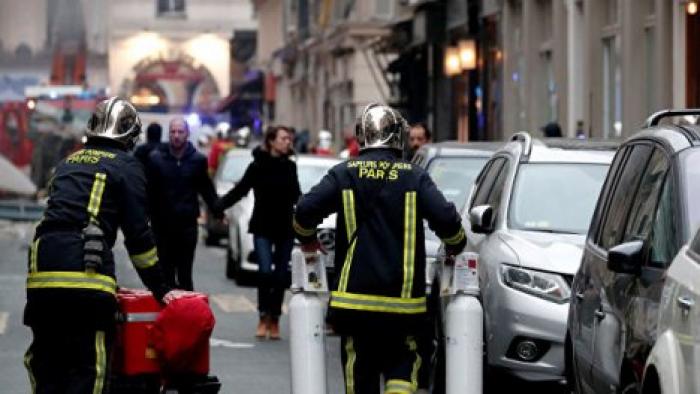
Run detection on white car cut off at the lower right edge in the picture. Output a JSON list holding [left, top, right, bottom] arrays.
[[641, 231, 700, 394]]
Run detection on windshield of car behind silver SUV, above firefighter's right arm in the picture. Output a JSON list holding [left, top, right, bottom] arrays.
[[428, 157, 488, 211]]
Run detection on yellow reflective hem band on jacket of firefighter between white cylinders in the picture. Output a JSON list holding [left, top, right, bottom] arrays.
[[330, 291, 426, 314]]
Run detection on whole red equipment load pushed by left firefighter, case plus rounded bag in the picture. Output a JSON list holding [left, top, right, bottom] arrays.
[[114, 289, 215, 376]]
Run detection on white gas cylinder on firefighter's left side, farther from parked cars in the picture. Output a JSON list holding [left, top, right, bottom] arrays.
[[289, 250, 328, 394]]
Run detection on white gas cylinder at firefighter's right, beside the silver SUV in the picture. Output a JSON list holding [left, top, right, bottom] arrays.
[[441, 252, 484, 394]]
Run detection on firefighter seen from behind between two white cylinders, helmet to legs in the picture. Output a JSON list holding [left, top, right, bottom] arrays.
[[293, 104, 466, 394]]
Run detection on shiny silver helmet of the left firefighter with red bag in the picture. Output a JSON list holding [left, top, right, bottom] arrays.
[[85, 97, 141, 149]]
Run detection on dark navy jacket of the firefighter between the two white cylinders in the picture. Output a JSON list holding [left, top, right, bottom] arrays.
[[293, 149, 466, 335]]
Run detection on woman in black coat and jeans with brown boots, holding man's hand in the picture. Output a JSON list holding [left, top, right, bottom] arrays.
[[217, 126, 301, 339]]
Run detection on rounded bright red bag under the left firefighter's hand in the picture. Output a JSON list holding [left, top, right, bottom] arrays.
[[151, 293, 216, 375]]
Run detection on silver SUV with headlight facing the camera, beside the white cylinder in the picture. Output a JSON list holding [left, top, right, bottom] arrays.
[[462, 132, 617, 384]]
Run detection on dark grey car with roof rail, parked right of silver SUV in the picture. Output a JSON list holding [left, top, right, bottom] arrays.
[[566, 111, 700, 393]]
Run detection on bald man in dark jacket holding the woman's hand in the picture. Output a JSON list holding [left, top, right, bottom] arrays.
[[146, 118, 223, 291]]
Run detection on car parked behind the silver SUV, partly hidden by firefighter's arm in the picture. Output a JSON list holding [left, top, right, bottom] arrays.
[[412, 141, 503, 294]]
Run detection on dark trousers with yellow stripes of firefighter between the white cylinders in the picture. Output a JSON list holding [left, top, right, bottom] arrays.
[[341, 334, 421, 394]]
